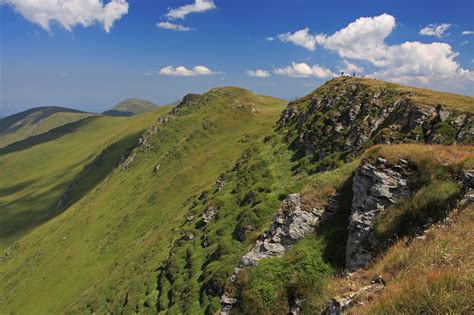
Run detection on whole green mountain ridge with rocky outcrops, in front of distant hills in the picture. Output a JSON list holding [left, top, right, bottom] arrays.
[[0, 78, 474, 314]]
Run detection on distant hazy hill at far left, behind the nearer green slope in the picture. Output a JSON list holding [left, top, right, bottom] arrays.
[[0, 106, 94, 148]]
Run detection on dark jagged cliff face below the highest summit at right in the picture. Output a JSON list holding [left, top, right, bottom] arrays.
[[278, 78, 474, 169]]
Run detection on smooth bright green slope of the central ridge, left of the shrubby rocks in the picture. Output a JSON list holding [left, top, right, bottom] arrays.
[[0, 88, 285, 314]]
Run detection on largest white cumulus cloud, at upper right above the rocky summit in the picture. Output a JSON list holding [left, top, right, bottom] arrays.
[[278, 14, 474, 89]]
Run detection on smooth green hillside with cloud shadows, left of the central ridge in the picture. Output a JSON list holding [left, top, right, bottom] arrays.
[[0, 109, 167, 248]]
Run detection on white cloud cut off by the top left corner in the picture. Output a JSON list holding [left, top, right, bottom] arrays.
[[0, 0, 129, 33]]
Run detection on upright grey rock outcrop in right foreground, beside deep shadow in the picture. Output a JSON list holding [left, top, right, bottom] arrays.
[[346, 158, 411, 271]]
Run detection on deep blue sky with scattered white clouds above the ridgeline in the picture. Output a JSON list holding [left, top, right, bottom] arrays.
[[0, 0, 474, 115]]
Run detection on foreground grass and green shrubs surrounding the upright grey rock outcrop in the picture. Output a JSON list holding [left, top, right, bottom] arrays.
[[234, 144, 474, 314]]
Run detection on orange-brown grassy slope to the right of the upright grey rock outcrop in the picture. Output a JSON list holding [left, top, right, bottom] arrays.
[[344, 145, 474, 314]]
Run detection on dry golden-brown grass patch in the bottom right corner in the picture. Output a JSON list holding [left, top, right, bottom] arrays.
[[351, 206, 474, 314]]
